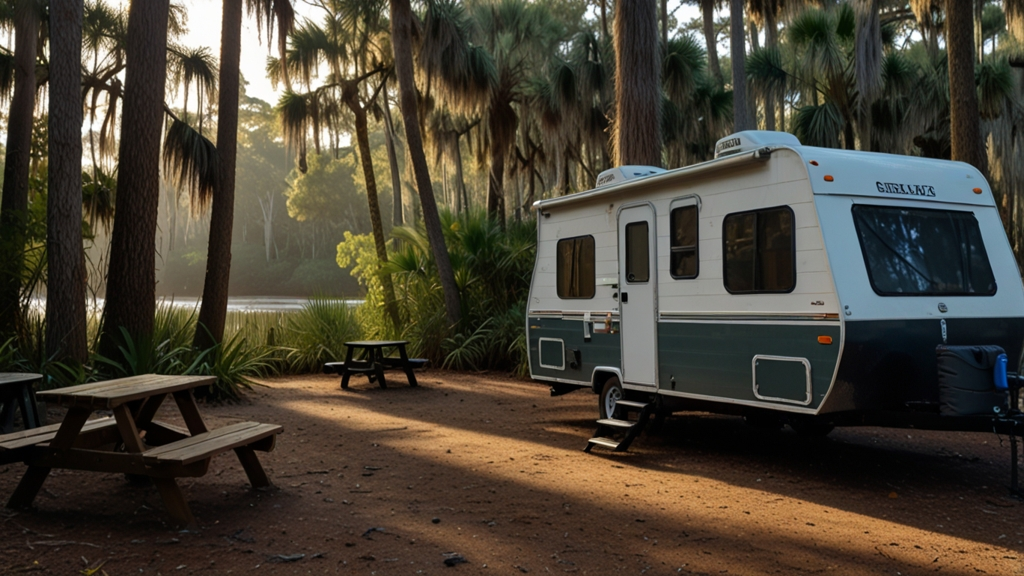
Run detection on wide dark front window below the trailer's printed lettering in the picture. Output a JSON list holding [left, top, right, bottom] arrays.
[[853, 204, 995, 296]]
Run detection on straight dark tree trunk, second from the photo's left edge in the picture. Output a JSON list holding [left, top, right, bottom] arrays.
[[46, 0, 89, 364]]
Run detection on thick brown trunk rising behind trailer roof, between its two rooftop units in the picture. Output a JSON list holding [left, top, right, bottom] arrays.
[[613, 0, 662, 166]]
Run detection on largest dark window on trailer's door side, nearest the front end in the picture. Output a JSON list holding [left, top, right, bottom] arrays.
[[722, 206, 797, 294]]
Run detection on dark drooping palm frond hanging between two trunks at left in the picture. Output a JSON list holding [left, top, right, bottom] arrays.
[[163, 118, 219, 212]]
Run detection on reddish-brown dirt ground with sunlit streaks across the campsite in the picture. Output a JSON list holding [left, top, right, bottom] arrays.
[[0, 371, 1024, 576]]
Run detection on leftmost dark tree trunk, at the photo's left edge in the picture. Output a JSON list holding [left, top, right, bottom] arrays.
[[0, 0, 39, 335]]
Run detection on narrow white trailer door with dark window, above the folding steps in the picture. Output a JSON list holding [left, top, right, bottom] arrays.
[[618, 204, 657, 387]]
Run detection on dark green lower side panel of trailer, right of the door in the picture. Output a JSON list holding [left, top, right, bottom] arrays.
[[658, 322, 840, 409]]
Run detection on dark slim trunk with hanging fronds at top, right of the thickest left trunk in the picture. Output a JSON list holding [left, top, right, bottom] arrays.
[[193, 0, 295, 349]]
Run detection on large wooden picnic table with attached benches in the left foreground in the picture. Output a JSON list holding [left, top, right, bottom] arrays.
[[0, 374, 282, 525]]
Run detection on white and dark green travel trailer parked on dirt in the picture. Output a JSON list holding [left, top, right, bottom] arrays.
[[526, 131, 1024, 479]]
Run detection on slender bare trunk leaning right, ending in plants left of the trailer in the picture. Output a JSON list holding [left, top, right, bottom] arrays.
[[389, 0, 462, 326]]
